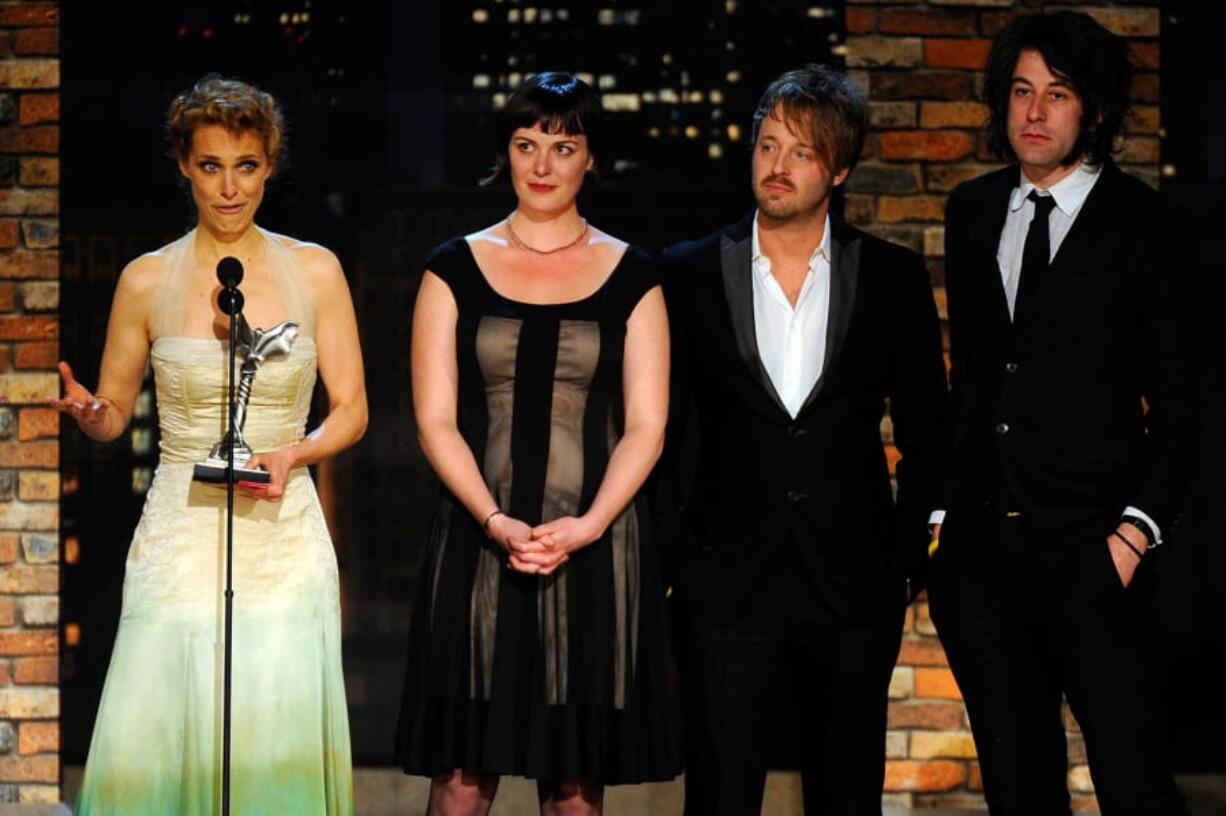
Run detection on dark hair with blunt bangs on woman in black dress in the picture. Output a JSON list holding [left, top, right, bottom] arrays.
[[481, 71, 604, 184]]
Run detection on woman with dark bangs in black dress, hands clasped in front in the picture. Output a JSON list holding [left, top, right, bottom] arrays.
[[397, 74, 679, 814]]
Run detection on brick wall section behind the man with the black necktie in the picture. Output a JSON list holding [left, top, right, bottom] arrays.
[[845, 0, 1160, 810]]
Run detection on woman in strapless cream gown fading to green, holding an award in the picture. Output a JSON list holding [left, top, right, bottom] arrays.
[[58, 78, 367, 816]]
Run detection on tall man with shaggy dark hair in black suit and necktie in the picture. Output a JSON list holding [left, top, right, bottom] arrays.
[[929, 12, 1199, 816]]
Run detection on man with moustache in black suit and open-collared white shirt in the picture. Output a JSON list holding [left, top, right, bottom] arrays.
[[657, 66, 946, 816]]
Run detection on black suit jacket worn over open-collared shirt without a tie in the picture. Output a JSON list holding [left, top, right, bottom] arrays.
[[655, 213, 946, 620]]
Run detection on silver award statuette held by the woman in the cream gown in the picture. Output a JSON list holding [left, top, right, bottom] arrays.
[[191, 314, 298, 484]]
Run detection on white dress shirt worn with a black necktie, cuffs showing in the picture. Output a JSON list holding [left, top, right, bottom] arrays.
[[928, 162, 1162, 544]]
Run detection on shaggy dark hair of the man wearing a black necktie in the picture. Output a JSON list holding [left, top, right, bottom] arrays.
[[982, 11, 1133, 165]]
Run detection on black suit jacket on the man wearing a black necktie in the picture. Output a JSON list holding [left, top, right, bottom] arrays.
[[942, 163, 1200, 548]]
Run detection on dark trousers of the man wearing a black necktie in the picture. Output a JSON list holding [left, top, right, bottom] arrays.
[[928, 508, 1187, 816]]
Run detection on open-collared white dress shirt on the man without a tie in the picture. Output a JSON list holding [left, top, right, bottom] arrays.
[[752, 214, 830, 418]]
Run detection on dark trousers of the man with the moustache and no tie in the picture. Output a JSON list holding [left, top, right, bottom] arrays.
[[679, 539, 904, 816]]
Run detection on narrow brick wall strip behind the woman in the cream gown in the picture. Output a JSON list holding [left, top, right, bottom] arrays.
[[0, 0, 60, 803]]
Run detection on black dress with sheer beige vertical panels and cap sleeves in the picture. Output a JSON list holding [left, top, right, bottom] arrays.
[[397, 238, 680, 784]]
